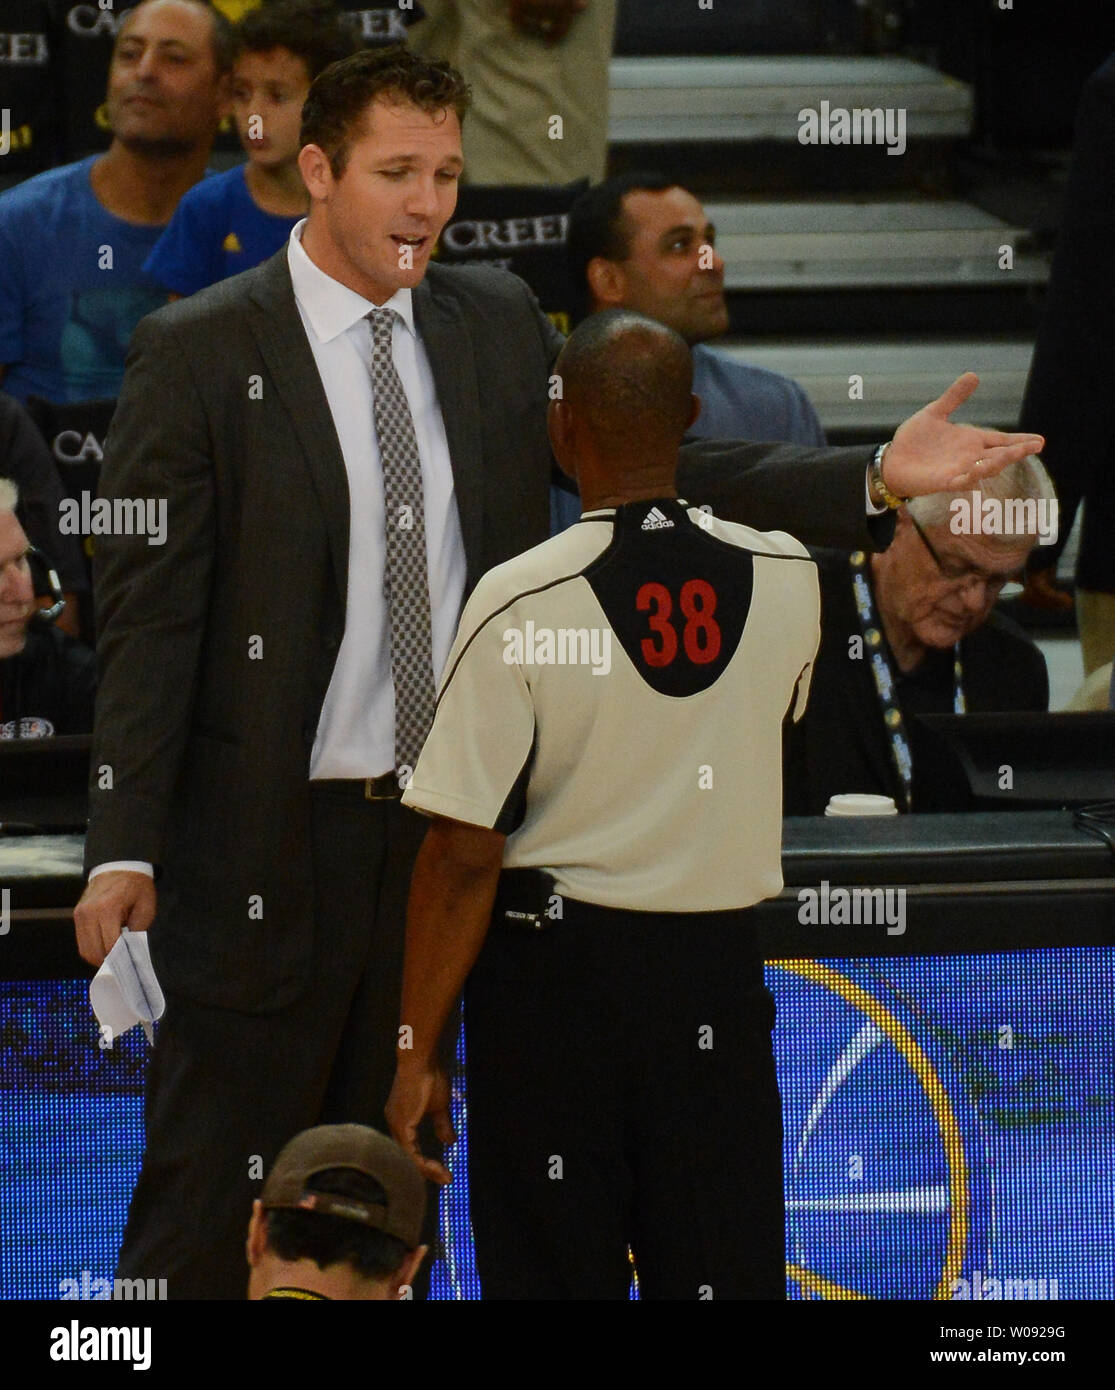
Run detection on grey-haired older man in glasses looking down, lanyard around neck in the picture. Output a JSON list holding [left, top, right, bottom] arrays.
[[784, 456, 1057, 816]]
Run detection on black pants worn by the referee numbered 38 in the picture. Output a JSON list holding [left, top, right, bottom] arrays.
[[464, 898, 786, 1300]]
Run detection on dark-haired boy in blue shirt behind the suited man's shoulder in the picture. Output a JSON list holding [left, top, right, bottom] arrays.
[[143, 0, 357, 297]]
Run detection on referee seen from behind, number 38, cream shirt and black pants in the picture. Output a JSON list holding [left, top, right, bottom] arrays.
[[386, 310, 819, 1298]]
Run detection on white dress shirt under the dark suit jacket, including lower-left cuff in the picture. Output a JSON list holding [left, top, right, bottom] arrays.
[[89, 218, 466, 878]]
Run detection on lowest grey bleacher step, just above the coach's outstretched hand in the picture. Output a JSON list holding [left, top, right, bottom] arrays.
[[716, 338, 1033, 436]]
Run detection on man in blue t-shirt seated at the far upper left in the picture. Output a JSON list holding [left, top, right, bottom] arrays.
[[0, 0, 231, 403]]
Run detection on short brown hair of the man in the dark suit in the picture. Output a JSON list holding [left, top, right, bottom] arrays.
[[300, 47, 470, 178]]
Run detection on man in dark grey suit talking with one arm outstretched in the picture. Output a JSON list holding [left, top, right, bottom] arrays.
[[75, 50, 1040, 1298]]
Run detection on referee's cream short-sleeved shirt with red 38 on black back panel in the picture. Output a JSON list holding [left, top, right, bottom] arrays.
[[403, 500, 820, 912]]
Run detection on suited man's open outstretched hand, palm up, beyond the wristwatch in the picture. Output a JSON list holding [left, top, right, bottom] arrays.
[[883, 371, 1045, 498]]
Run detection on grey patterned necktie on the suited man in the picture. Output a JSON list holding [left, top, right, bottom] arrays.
[[367, 309, 434, 769]]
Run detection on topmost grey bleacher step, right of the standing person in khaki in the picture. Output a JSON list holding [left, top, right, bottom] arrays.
[[609, 56, 973, 145]]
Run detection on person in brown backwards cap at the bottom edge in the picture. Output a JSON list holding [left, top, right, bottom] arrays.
[[247, 1125, 427, 1301]]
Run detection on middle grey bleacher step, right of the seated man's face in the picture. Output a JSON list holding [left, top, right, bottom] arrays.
[[705, 200, 1048, 291]]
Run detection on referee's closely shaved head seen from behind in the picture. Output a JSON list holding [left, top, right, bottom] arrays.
[[555, 309, 692, 461]]
